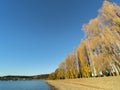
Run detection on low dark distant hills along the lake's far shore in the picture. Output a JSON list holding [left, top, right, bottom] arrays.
[[0, 74, 49, 80]]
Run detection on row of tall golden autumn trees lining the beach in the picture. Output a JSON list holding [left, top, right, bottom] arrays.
[[49, 1, 120, 79]]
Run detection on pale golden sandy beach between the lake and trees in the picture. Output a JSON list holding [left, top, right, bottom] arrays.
[[47, 76, 120, 90]]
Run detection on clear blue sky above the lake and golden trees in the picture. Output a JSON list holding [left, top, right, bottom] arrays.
[[0, 0, 120, 76]]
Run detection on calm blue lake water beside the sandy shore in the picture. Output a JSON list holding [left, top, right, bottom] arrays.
[[0, 80, 51, 90]]
